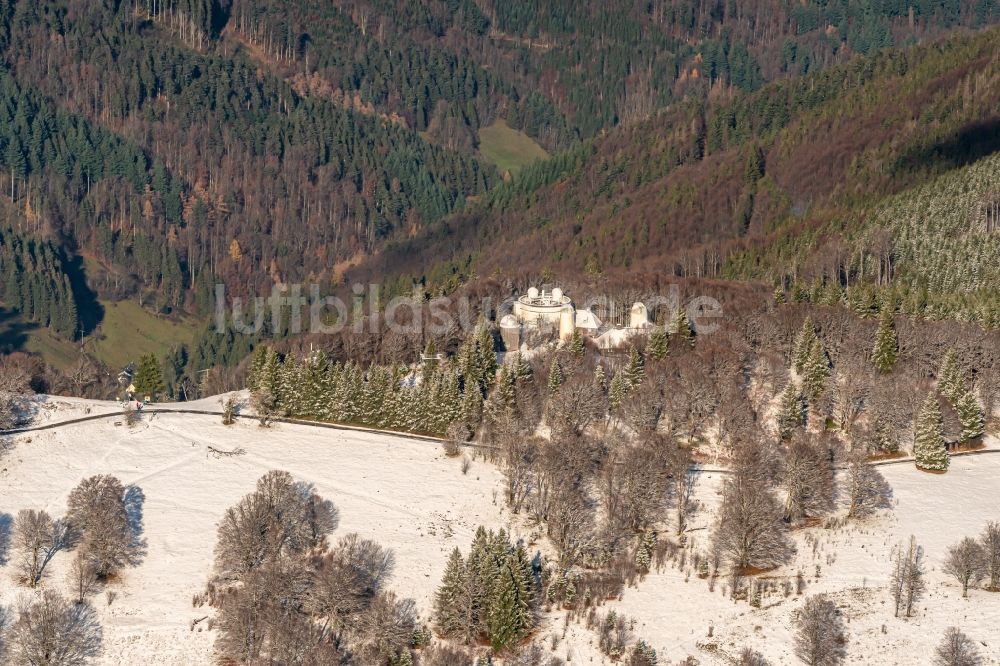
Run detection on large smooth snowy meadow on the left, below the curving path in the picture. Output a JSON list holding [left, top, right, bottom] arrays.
[[0, 398, 502, 666]]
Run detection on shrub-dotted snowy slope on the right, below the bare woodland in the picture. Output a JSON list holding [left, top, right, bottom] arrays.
[[592, 454, 1000, 666]]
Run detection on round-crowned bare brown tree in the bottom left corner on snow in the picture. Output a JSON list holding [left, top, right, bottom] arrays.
[[8, 590, 102, 666]]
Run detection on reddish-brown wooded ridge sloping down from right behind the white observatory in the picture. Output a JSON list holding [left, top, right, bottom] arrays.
[[373, 25, 1000, 321]]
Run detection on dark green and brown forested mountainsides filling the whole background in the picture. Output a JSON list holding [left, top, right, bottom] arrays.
[[0, 0, 1000, 374]]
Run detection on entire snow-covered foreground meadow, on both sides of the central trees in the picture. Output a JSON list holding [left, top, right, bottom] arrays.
[[0, 398, 1000, 666]]
